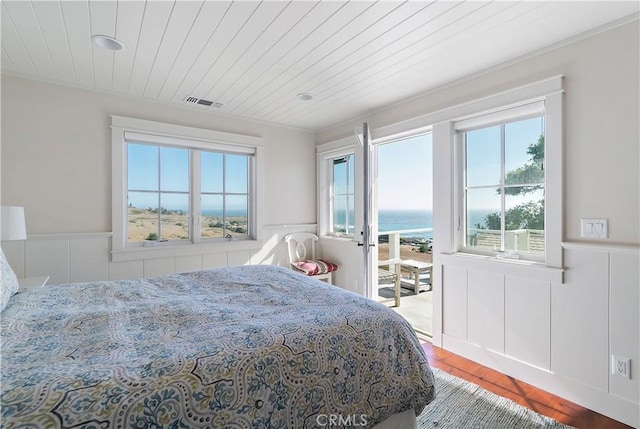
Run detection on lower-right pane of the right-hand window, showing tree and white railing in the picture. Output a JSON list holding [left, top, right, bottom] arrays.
[[505, 187, 544, 254]]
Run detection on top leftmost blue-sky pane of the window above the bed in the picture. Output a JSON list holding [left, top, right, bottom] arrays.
[[127, 143, 160, 191]]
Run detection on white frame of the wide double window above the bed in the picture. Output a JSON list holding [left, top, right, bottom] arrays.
[[111, 115, 264, 261]]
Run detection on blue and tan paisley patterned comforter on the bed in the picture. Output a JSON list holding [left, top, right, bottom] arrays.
[[1, 266, 434, 429]]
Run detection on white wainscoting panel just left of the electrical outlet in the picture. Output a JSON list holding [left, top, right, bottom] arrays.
[[551, 250, 609, 391]]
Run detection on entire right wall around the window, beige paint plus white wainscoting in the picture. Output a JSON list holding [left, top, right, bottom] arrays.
[[318, 20, 640, 427]]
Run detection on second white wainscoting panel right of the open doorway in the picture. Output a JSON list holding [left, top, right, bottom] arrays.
[[467, 270, 504, 353]]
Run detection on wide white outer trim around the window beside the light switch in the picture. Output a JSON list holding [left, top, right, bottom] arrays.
[[432, 76, 564, 270]]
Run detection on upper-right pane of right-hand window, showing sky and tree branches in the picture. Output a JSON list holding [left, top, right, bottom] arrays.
[[504, 117, 544, 185]]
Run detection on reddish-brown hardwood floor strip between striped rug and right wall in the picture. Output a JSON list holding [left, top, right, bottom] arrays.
[[422, 341, 631, 429]]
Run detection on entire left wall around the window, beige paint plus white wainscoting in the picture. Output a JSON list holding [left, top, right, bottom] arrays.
[[1, 75, 316, 283]]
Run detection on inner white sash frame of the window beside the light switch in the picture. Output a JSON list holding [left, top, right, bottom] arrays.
[[453, 101, 547, 262]]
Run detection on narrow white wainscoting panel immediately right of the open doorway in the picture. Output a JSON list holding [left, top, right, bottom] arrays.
[[442, 266, 468, 340]]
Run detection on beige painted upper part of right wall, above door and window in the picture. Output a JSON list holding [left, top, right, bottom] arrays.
[[318, 21, 640, 244]]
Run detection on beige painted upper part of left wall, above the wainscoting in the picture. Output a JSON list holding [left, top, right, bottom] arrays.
[[1, 75, 316, 235]]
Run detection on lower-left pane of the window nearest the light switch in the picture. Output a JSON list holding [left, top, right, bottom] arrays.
[[465, 189, 501, 250]]
